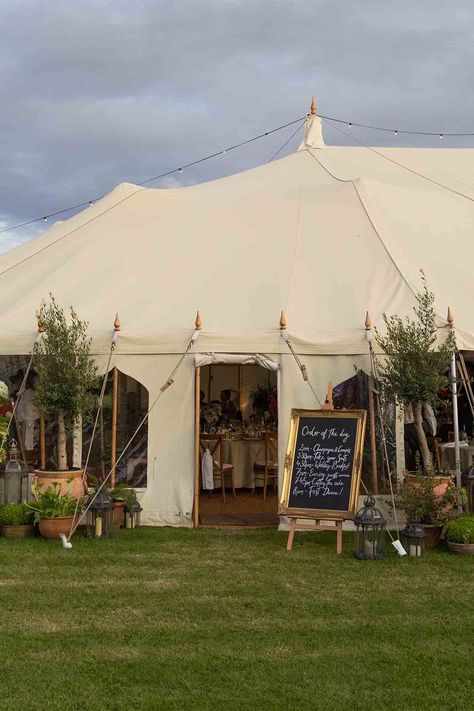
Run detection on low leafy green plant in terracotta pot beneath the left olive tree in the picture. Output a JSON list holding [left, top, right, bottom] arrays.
[[26, 483, 81, 540]]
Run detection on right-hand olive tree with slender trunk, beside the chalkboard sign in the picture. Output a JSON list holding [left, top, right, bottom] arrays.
[[376, 272, 455, 478]]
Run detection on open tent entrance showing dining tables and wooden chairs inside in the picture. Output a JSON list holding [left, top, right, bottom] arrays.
[[194, 354, 278, 526]]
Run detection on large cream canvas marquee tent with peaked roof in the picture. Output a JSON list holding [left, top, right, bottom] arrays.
[[0, 110, 474, 526]]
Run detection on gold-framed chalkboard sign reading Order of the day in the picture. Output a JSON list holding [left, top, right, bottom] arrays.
[[279, 410, 366, 519]]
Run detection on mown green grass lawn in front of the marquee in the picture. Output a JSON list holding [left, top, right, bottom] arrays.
[[0, 528, 474, 711]]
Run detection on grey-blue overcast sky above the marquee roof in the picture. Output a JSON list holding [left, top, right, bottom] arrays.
[[0, 0, 474, 251]]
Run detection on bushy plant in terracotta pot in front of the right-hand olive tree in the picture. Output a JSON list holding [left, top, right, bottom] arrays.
[[395, 477, 460, 548]]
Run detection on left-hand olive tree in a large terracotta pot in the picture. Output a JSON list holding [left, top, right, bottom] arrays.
[[34, 296, 97, 496]]
